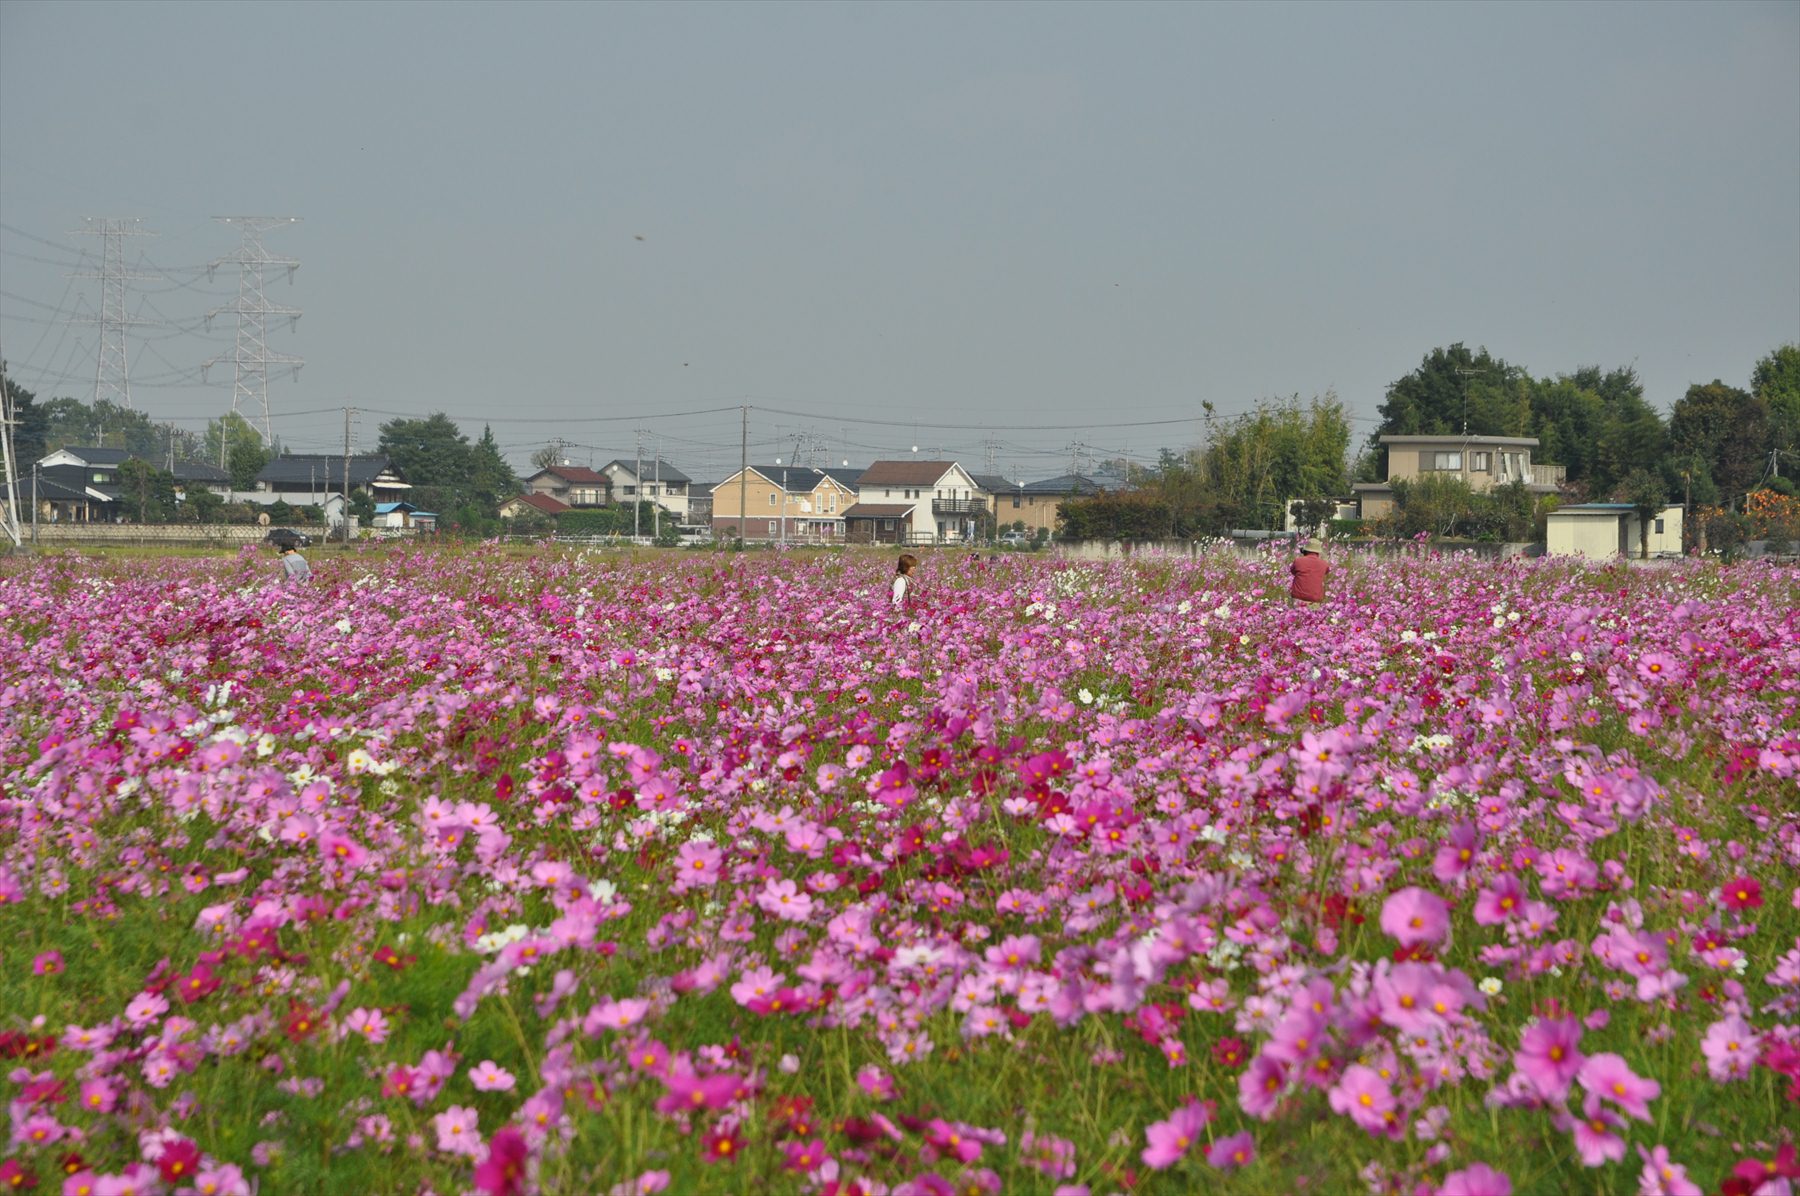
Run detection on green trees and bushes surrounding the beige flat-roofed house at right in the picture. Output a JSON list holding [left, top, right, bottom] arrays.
[[1058, 336, 1800, 540]]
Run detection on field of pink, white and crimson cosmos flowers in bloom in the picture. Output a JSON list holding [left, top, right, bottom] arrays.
[[0, 546, 1800, 1196]]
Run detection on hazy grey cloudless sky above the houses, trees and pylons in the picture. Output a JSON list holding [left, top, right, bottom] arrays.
[[0, 0, 1800, 481]]
